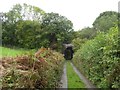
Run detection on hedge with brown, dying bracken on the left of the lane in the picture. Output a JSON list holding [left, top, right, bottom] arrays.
[[0, 48, 64, 89]]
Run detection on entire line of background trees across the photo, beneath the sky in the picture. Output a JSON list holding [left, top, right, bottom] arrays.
[[1, 4, 118, 50]]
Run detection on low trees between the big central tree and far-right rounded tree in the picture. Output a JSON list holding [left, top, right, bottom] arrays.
[[72, 27, 97, 51]]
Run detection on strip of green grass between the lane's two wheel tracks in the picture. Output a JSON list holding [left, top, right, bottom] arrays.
[[66, 61, 85, 88]]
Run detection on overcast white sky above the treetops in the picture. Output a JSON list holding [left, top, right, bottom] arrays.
[[0, 0, 120, 30]]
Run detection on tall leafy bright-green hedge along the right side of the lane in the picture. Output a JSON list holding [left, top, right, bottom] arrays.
[[73, 27, 120, 88]]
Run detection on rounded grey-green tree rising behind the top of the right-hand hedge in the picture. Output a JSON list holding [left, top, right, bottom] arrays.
[[93, 11, 118, 32]]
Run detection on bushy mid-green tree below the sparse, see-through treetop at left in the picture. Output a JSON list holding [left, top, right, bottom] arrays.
[[15, 20, 41, 49]]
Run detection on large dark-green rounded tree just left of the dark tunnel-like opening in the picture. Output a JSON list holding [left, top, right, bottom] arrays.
[[42, 13, 73, 49]]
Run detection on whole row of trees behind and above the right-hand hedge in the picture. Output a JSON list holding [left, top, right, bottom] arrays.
[[72, 11, 118, 50]]
